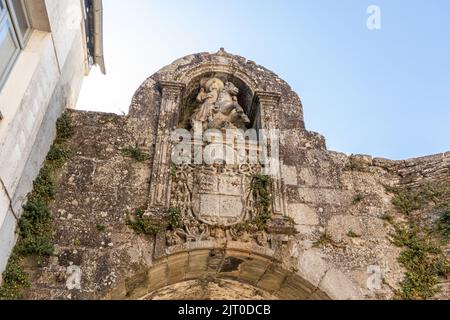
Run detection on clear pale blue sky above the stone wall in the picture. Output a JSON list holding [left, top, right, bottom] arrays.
[[77, 0, 450, 159]]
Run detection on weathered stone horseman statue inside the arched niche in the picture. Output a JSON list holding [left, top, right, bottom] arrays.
[[191, 78, 250, 129]]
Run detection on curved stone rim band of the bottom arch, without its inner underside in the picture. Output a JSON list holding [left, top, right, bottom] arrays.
[[105, 241, 332, 300]]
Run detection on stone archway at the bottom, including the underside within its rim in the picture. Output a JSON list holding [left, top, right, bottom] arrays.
[[106, 242, 331, 300]]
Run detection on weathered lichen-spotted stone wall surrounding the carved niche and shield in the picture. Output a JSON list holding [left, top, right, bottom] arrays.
[[14, 52, 450, 299]]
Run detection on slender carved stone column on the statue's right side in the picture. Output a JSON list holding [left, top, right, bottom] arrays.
[[255, 91, 286, 216]]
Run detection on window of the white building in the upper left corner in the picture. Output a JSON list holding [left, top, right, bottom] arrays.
[[0, 0, 31, 89]]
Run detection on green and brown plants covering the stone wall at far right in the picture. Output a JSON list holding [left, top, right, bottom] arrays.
[[386, 183, 450, 300]]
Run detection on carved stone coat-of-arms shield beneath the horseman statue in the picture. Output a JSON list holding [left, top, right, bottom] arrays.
[[172, 165, 261, 227]]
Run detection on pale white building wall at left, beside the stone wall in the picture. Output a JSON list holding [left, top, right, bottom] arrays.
[[0, 0, 90, 274]]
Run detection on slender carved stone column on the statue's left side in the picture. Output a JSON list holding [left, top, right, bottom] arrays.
[[149, 81, 185, 212]]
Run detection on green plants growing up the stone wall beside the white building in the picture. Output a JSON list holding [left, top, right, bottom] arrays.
[[0, 113, 74, 300]]
